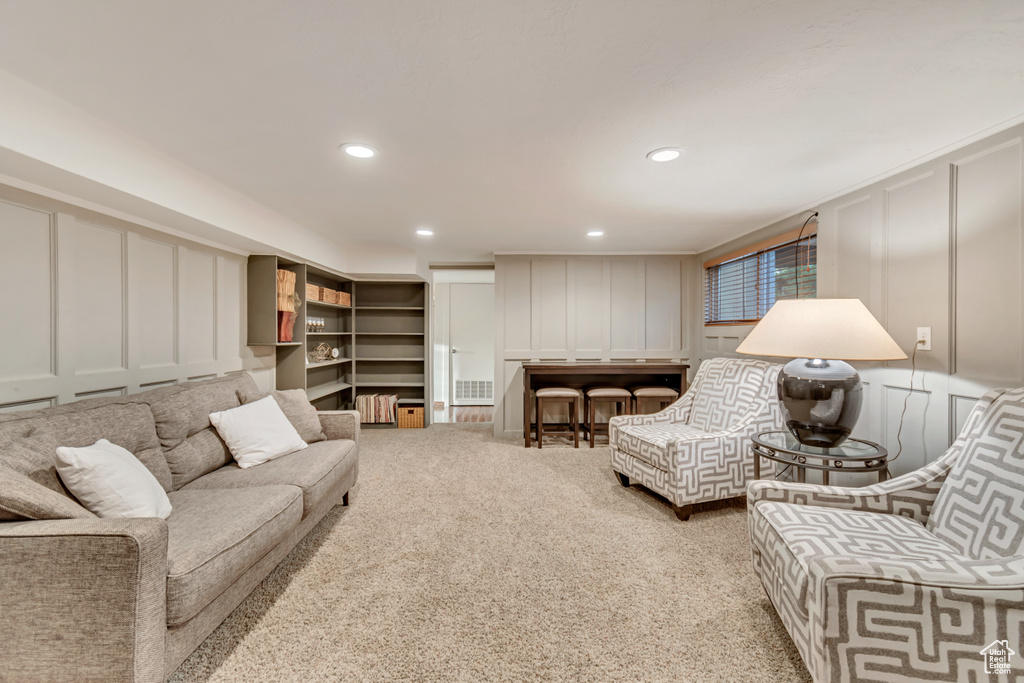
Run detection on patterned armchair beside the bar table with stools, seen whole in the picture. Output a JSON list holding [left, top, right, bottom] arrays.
[[609, 358, 785, 520]]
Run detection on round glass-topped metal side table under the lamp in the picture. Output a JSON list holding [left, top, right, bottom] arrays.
[[751, 431, 889, 486]]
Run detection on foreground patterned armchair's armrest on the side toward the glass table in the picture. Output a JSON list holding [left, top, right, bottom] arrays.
[[746, 454, 956, 524]]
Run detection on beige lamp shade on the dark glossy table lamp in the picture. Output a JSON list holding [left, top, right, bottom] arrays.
[[736, 299, 906, 360]]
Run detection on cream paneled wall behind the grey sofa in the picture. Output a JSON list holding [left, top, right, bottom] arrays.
[[0, 186, 273, 411]]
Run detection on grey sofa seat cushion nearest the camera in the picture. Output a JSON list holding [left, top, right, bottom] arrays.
[[167, 486, 302, 627]]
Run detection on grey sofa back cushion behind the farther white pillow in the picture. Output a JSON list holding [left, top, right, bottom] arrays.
[[148, 374, 258, 490]]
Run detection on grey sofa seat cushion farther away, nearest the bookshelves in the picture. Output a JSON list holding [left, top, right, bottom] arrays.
[[182, 439, 359, 519]]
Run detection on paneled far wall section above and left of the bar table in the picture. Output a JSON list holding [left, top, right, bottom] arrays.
[[495, 255, 699, 436]]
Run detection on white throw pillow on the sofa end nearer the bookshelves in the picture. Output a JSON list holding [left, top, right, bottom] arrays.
[[210, 396, 308, 469]]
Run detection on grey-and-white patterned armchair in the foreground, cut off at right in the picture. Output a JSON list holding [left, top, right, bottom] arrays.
[[746, 389, 1024, 682]]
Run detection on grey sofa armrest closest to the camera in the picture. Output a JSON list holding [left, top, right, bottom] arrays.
[[0, 517, 167, 683]]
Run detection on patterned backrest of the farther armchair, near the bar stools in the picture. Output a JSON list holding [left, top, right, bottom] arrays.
[[687, 358, 778, 432]]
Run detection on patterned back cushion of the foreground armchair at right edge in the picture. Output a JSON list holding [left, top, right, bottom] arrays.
[[928, 389, 1024, 559]]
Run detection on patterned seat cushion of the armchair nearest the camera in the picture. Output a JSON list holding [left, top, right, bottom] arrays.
[[751, 502, 970, 618]]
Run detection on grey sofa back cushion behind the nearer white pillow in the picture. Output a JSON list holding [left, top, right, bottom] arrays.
[[0, 396, 172, 490]]
